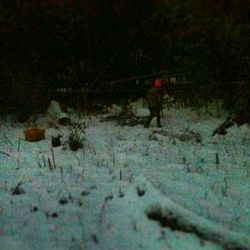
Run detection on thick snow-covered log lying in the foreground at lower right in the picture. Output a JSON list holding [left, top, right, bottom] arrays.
[[143, 187, 250, 250]]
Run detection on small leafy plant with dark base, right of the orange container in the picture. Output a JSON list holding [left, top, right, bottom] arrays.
[[68, 122, 86, 151]]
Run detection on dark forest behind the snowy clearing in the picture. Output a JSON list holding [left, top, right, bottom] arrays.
[[0, 0, 250, 117]]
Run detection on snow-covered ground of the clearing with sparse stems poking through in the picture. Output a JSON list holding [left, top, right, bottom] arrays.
[[0, 102, 250, 250]]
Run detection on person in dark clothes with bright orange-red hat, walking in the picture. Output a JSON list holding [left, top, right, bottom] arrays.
[[145, 79, 164, 128]]
